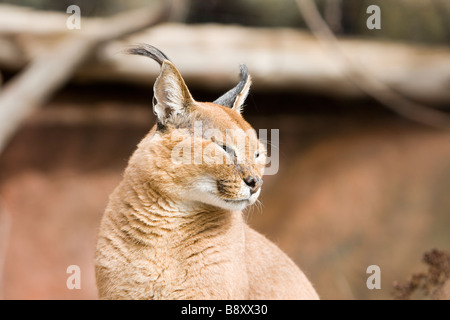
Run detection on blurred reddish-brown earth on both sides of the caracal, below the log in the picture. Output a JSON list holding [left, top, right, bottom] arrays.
[[0, 85, 450, 299]]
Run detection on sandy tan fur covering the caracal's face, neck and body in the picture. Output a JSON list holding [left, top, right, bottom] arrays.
[[95, 45, 318, 299]]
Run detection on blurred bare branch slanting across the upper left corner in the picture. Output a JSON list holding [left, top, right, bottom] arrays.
[[0, 1, 170, 153]]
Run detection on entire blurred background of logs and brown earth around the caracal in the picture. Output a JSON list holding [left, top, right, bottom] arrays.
[[0, 0, 450, 299]]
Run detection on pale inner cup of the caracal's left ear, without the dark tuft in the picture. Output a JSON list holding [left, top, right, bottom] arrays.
[[153, 60, 195, 125]]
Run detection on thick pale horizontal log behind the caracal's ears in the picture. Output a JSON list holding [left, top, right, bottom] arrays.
[[0, 4, 450, 106]]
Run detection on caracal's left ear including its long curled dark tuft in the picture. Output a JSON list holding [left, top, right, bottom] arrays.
[[126, 44, 195, 126]]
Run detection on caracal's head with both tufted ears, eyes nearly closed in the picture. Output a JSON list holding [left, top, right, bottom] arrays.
[[129, 45, 266, 210]]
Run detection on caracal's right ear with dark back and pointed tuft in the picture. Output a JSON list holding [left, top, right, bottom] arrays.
[[214, 64, 252, 114]]
